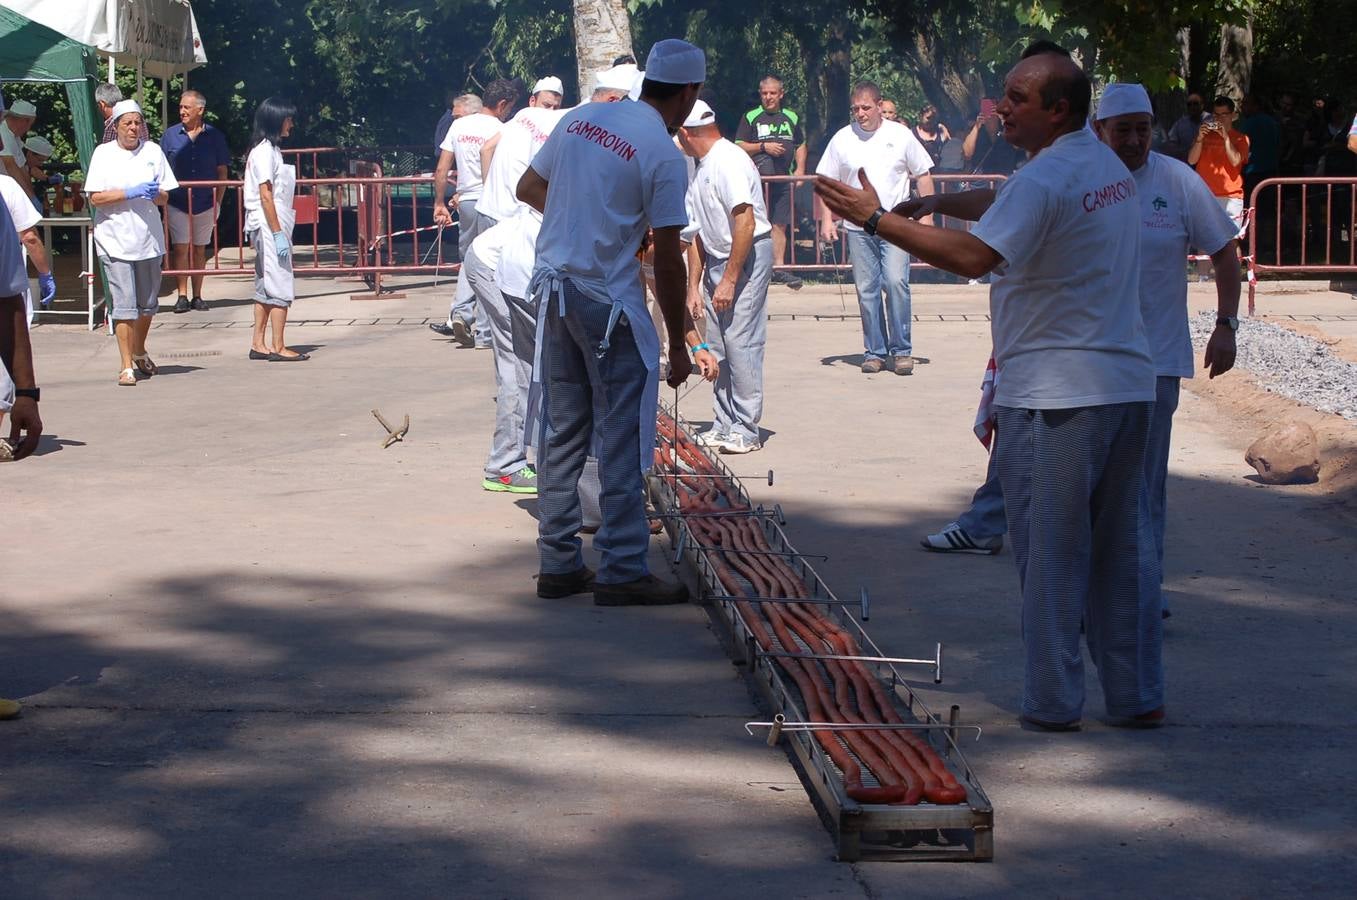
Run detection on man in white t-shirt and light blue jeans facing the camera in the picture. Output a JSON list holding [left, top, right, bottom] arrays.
[[816, 81, 934, 375]]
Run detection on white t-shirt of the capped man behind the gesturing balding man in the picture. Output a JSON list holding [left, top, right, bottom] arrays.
[[1132, 153, 1239, 379]]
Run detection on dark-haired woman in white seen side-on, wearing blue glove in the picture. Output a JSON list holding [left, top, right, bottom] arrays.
[[244, 96, 311, 362]]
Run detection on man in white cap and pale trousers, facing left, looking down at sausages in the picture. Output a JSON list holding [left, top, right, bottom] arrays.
[[679, 100, 772, 453]]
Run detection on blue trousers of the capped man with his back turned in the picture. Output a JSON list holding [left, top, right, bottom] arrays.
[[537, 285, 651, 584]]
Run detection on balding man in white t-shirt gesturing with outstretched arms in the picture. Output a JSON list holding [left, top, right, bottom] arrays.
[[816, 43, 1164, 732]]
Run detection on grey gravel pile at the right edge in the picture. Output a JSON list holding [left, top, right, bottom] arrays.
[[1189, 312, 1357, 419]]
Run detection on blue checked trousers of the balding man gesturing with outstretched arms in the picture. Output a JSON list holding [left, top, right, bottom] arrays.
[[995, 402, 1164, 722]]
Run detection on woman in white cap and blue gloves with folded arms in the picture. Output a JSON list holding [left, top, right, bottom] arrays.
[[84, 100, 179, 387]]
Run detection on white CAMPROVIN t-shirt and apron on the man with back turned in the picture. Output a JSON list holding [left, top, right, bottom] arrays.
[[528, 100, 688, 471]]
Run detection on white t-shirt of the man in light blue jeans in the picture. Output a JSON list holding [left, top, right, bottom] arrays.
[[816, 119, 932, 231]]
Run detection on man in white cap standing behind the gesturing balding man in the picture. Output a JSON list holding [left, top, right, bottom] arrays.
[[923, 83, 1239, 627]]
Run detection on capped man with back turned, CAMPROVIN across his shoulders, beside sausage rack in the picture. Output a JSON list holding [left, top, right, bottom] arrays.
[[517, 41, 707, 605]]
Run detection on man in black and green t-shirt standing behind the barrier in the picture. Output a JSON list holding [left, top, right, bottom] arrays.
[[735, 75, 806, 290]]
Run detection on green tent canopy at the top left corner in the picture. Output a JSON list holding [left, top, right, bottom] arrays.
[[0, 7, 103, 170]]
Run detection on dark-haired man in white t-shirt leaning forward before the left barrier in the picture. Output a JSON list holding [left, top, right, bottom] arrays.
[[429, 79, 518, 349]]
